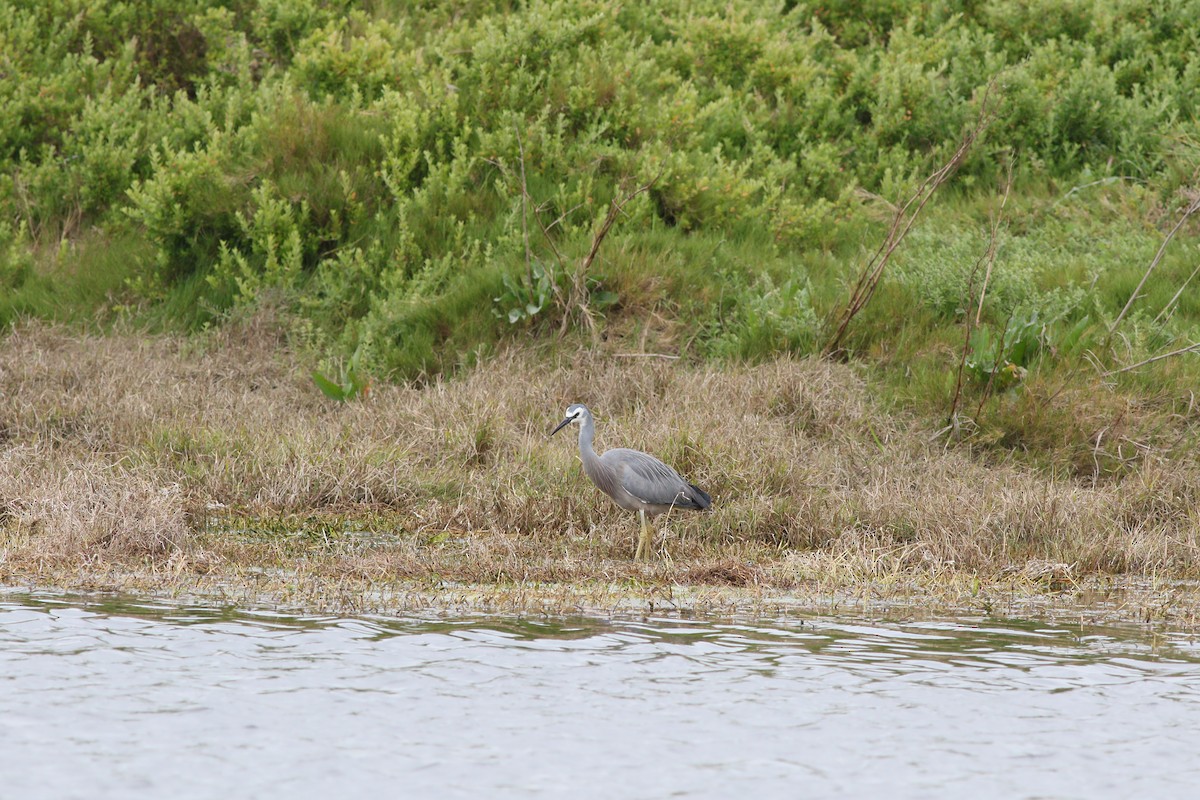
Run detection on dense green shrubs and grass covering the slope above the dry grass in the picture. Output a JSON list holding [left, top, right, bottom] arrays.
[[0, 0, 1200, 470]]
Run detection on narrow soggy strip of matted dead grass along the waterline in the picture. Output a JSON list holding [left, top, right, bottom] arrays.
[[0, 560, 1200, 631]]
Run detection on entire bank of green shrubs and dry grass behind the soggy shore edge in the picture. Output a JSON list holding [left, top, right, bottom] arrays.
[[0, 0, 1200, 613]]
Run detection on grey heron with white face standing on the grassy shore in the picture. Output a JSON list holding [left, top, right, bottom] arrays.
[[550, 403, 713, 561]]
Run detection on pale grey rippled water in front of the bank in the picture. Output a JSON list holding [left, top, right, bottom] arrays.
[[0, 593, 1200, 800]]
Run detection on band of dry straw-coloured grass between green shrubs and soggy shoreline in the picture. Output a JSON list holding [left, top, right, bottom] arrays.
[[0, 318, 1200, 618]]
